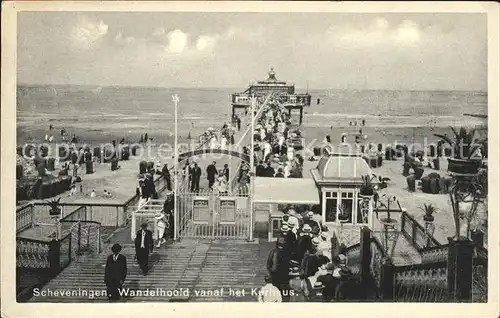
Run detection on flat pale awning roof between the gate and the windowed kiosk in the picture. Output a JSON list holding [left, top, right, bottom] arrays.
[[254, 177, 320, 204]]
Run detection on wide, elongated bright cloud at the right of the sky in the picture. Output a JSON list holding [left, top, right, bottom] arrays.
[[327, 18, 422, 47]]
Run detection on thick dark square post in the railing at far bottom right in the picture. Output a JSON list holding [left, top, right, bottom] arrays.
[[447, 237, 474, 302]]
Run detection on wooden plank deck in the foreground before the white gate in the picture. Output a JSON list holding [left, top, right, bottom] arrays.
[[30, 240, 273, 303]]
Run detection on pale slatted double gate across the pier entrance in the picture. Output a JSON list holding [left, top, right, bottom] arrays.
[[176, 189, 252, 239]]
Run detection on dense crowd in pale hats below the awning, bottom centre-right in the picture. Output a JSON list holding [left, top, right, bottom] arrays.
[[259, 207, 362, 302]]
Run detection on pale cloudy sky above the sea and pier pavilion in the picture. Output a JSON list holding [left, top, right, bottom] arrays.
[[18, 12, 487, 90]]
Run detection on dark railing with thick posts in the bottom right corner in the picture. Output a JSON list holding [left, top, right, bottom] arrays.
[[346, 227, 488, 302]]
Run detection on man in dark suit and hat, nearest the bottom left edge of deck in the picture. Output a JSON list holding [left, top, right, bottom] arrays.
[[104, 244, 127, 301]]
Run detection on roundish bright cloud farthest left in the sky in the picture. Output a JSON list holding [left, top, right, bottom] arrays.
[[71, 17, 108, 50]]
